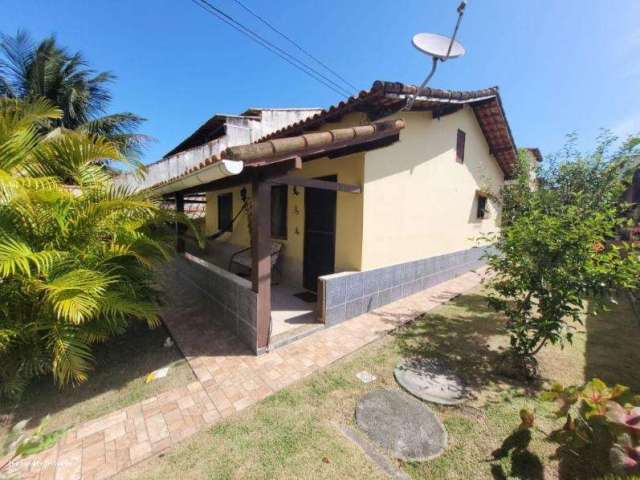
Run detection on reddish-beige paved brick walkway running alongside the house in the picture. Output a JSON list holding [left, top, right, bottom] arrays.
[[3, 272, 481, 480]]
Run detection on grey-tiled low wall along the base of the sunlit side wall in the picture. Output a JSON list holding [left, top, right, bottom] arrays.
[[318, 247, 491, 325]]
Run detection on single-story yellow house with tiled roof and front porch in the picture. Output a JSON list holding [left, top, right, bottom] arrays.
[[153, 81, 518, 353]]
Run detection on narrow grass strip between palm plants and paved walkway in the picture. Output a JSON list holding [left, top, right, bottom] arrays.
[[0, 323, 195, 456]]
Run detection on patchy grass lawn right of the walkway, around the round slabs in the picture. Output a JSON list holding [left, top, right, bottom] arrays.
[[119, 290, 640, 480]]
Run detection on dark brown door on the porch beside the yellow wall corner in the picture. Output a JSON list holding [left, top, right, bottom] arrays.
[[302, 175, 337, 292]]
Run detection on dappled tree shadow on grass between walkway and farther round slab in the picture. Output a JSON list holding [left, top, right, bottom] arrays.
[[394, 294, 537, 391]]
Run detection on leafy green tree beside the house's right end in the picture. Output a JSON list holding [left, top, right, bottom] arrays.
[[483, 136, 640, 375]]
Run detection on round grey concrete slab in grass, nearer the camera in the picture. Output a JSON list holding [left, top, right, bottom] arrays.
[[356, 389, 447, 462]]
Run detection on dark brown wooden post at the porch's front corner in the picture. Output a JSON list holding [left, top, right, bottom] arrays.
[[251, 177, 271, 349]]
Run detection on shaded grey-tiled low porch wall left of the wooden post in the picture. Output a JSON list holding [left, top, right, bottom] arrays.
[[176, 253, 258, 353]]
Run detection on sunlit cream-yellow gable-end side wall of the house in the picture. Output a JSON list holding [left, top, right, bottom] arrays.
[[362, 107, 504, 270]]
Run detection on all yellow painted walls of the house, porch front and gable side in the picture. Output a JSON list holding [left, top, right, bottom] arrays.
[[206, 107, 504, 285]]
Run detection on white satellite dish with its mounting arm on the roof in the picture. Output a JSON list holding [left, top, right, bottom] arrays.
[[403, 0, 467, 110]]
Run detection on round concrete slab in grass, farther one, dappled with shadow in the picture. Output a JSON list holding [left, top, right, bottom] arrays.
[[394, 358, 468, 405]]
